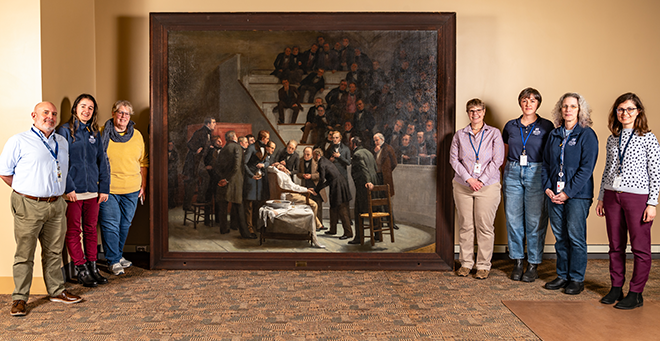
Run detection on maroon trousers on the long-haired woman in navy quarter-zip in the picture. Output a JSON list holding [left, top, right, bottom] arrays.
[[64, 198, 99, 265]]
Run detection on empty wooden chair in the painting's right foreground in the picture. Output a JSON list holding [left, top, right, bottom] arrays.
[[356, 184, 394, 246]]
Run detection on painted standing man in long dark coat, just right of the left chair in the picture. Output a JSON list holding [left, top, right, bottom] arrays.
[[213, 131, 257, 239]]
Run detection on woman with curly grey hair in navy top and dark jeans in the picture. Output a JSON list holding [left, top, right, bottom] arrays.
[[543, 93, 598, 295]]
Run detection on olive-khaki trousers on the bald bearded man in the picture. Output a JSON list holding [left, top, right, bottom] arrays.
[[11, 192, 66, 302]]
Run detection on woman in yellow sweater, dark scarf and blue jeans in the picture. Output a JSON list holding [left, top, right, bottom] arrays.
[[99, 100, 149, 276]]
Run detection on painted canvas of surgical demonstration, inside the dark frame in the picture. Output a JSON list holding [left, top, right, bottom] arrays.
[[167, 31, 438, 253]]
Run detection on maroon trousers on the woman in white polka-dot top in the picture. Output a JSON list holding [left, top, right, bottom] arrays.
[[603, 190, 653, 293]]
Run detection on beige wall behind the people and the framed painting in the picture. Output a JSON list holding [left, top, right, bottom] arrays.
[[0, 0, 660, 292]]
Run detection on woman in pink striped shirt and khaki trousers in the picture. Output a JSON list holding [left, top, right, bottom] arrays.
[[449, 98, 504, 279]]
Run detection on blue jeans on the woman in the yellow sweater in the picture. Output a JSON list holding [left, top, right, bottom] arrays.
[[99, 191, 140, 265]]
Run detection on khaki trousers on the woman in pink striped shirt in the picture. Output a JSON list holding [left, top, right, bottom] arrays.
[[452, 180, 502, 270]]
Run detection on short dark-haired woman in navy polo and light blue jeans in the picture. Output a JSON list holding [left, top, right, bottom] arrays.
[[502, 88, 554, 282]]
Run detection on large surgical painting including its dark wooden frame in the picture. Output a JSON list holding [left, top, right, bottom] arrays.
[[150, 13, 456, 270]]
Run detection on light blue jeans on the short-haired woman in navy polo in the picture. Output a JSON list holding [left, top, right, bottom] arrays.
[[503, 161, 548, 264]]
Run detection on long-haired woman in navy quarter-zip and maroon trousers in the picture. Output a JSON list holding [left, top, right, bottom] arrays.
[[57, 94, 110, 287]]
